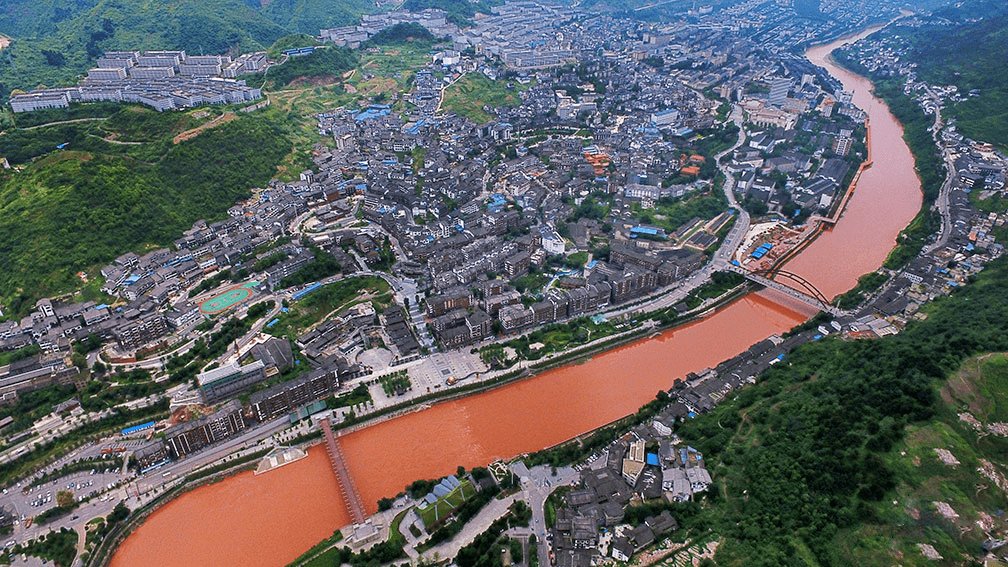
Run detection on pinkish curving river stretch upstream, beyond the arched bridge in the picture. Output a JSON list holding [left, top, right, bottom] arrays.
[[786, 37, 921, 298]]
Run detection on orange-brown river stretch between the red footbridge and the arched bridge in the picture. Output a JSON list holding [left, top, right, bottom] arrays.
[[342, 294, 810, 512]]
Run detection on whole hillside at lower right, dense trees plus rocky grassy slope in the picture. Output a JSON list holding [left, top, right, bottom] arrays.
[[678, 254, 1008, 566]]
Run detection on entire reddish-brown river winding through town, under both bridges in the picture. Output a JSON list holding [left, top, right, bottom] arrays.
[[112, 27, 921, 567]]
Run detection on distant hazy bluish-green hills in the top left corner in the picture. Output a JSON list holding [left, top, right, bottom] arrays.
[[0, 0, 372, 100]]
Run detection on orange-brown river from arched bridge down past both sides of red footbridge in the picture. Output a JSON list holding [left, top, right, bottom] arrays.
[[106, 293, 810, 567]]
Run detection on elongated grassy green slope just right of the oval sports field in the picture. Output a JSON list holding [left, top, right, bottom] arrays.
[[265, 274, 389, 337]]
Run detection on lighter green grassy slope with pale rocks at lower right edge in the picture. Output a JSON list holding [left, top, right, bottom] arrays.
[[826, 354, 1008, 565]]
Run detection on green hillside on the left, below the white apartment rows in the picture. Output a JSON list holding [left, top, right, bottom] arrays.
[[0, 106, 291, 314]]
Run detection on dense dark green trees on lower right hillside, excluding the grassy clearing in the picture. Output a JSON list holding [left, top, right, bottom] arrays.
[[665, 254, 1008, 566]]
